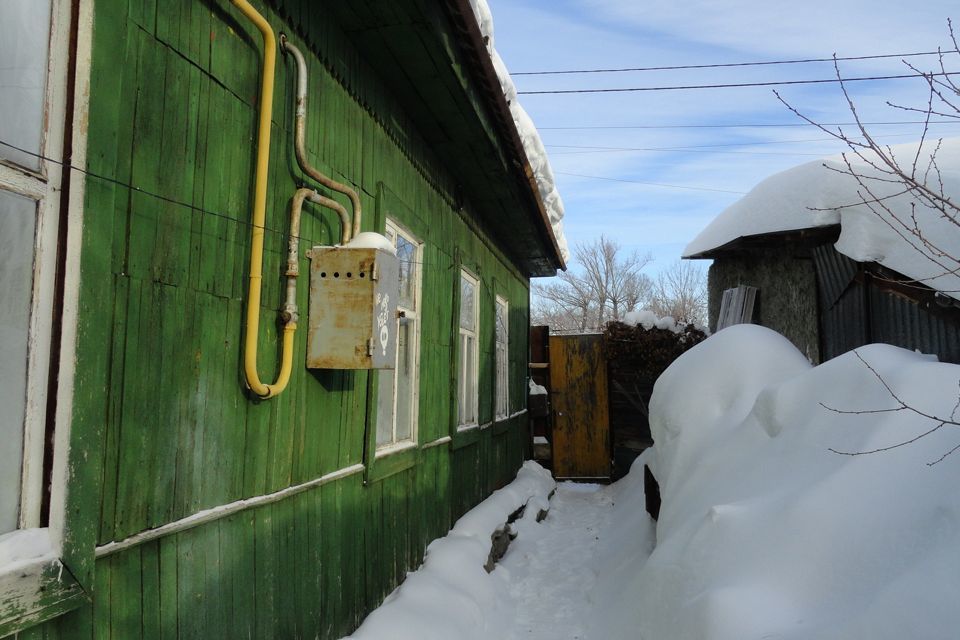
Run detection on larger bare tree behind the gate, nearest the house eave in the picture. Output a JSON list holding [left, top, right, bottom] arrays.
[[531, 236, 653, 332]]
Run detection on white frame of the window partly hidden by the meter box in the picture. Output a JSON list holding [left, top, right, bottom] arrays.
[[376, 218, 423, 457]]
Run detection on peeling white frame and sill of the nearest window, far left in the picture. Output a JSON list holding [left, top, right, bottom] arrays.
[[0, 0, 93, 633]]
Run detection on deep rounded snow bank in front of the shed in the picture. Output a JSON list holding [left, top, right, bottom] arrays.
[[632, 325, 960, 640]]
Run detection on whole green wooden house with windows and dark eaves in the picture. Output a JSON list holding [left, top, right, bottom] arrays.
[[0, 0, 563, 640]]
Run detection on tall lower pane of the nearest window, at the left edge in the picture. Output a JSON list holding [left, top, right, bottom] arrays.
[[0, 191, 37, 534]]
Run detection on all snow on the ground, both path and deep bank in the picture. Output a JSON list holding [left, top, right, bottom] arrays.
[[344, 325, 960, 640]]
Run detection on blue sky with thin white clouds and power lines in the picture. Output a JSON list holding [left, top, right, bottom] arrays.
[[489, 0, 960, 282]]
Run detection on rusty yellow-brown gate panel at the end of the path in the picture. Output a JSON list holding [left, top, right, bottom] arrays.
[[550, 334, 610, 480]]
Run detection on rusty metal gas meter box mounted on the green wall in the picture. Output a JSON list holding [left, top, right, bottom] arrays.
[[307, 247, 400, 369]]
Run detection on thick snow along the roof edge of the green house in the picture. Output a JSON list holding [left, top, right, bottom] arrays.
[[469, 0, 570, 263]]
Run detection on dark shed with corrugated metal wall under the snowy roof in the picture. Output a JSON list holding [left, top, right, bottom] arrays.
[[691, 226, 960, 363]]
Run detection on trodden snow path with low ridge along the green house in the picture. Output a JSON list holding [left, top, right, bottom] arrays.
[[351, 462, 654, 640]]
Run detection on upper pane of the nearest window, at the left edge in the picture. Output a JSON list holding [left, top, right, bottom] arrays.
[[0, 0, 50, 170]]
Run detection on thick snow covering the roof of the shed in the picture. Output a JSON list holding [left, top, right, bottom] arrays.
[[683, 138, 960, 299]]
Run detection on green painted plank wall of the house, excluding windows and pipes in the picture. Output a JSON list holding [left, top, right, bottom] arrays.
[[7, 0, 529, 640]]
